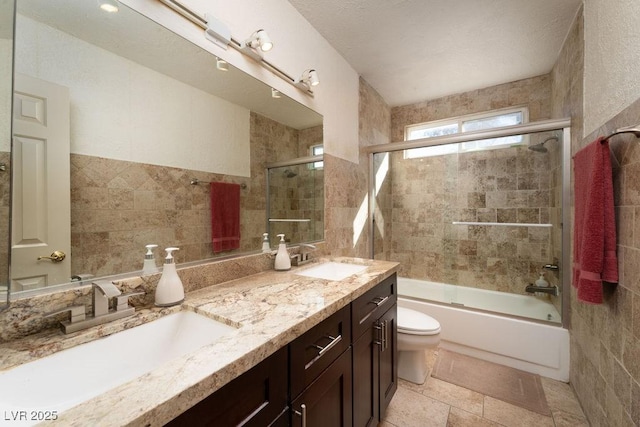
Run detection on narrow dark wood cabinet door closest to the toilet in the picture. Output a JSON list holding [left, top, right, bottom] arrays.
[[378, 304, 398, 419]]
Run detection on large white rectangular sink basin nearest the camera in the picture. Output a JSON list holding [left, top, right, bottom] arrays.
[[0, 311, 235, 425]]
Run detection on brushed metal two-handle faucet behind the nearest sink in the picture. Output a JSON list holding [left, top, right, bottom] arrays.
[[45, 281, 144, 334]]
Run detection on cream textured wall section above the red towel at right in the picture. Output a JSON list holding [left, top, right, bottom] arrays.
[[582, 0, 640, 137]]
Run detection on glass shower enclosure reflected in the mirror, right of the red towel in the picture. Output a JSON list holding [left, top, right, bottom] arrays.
[[266, 156, 324, 247]]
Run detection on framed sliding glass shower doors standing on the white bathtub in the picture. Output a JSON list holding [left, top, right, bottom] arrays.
[[369, 120, 570, 323]]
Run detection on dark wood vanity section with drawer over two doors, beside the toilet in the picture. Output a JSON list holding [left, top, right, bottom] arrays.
[[352, 275, 398, 427]]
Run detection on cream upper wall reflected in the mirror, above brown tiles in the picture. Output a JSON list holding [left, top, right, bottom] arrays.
[[15, 15, 251, 176]]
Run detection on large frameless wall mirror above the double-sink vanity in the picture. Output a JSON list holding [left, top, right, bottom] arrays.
[[3, 0, 322, 296]]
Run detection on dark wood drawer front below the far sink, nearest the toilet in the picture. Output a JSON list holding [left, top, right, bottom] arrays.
[[351, 274, 398, 341]]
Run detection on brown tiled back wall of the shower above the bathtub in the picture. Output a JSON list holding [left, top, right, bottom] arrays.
[[376, 75, 560, 293]]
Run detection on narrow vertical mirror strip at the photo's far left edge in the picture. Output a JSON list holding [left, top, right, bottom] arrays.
[[0, 0, 14, 309]]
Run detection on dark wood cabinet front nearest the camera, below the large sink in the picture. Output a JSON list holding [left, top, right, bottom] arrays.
[[167, 347, 288, 427]]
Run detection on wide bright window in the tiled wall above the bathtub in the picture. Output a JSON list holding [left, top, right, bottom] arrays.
[[404, 107, 529, 159]]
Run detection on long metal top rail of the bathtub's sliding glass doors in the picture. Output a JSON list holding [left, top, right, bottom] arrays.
[[363, 119, 571, 154]]
